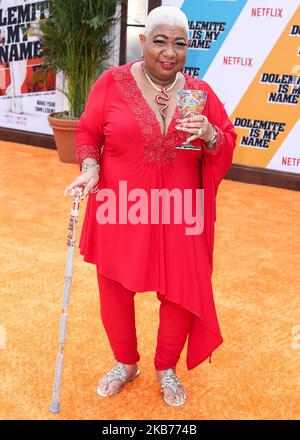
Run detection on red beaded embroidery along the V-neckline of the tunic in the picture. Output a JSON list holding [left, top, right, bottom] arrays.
[[112, 63, 207, 165]]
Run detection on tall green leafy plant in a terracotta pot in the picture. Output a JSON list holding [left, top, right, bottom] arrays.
[[40, 0, 121, 163]]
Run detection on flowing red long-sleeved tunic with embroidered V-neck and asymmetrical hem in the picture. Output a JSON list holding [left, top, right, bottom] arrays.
[[76, 63, 236, 370]]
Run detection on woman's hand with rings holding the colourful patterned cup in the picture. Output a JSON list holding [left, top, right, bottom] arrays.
[[176, 115, 214, 145]]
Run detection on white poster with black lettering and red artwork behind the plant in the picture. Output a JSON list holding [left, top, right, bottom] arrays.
[[0, 0, 62, 134]]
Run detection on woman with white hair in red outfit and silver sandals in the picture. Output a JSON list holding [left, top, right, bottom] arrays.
[[66, 6, 236, 406]]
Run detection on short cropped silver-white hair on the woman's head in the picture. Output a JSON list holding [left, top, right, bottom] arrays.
[[144, 6, 189, 37]]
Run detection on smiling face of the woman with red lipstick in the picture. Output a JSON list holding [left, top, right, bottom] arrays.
[[140, 25, 188, 83]]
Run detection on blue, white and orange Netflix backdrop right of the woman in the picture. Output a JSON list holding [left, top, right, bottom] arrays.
[[162, 0, 300, 173]]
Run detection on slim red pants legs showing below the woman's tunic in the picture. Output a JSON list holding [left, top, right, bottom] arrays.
[[97, 270, 192, 370]]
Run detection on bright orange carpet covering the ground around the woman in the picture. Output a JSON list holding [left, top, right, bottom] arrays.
[[0, 142, 300, 420]]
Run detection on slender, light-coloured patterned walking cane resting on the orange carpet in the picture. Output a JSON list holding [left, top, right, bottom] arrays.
[[50, 188, 83, 413]]
